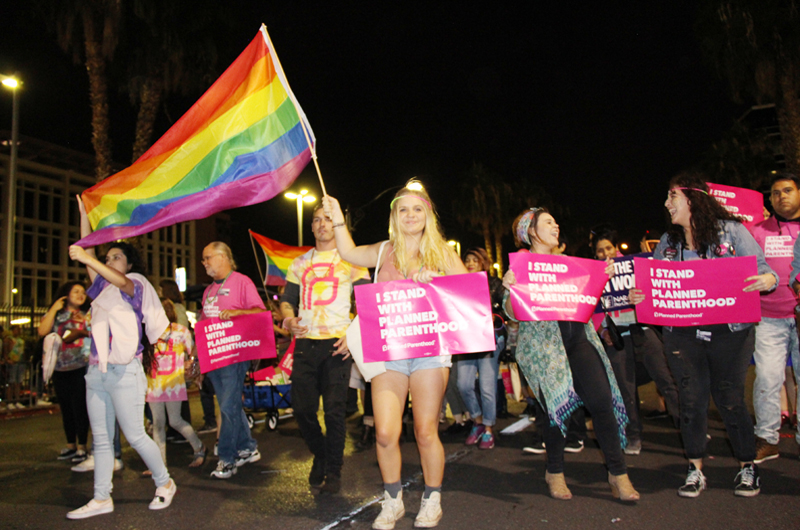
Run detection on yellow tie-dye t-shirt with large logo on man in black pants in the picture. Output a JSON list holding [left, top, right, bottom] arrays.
[[286, 249, 369, 339]]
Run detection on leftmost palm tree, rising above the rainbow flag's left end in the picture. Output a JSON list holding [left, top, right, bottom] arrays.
[[37, 0, 122, 181]]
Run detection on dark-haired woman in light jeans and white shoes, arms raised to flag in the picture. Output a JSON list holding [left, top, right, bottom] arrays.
[[67, 197, 177, 519]]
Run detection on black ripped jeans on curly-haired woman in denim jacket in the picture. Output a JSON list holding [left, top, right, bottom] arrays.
[[664, 325, 756, 462]]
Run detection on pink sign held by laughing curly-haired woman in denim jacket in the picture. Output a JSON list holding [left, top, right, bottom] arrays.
[[634, 256, 761, 326]]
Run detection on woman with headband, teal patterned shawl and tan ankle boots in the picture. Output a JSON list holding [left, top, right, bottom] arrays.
[[503, 208, 639, 501]]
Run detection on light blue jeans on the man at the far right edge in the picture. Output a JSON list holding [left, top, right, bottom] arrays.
[[753, 317, 800, 445]]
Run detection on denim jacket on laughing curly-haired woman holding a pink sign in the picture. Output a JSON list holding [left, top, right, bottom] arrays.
[[653, 221, 778, 331]]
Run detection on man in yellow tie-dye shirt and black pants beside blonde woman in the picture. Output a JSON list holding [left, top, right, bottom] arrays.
[[281, 205, 369, 493]]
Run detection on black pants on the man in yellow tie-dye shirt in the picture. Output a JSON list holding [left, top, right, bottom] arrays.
[[292, 339, 353, 476]]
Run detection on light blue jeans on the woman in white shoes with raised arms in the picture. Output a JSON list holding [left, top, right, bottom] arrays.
[[86, 359, 170, 501]]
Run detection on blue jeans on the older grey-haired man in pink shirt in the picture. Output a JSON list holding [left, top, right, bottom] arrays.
[[207, 361, 258, 464]]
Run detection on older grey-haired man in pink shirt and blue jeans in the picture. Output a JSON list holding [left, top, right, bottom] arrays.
[[198, 241, 266, 479]]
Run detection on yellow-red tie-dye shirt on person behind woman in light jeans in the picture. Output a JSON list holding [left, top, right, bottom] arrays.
[[145, 322, 194, 403]]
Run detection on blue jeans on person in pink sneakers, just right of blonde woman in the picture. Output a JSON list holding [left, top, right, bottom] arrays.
[[456, 337, 506, 427]]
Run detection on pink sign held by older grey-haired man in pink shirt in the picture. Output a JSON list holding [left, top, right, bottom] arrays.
[[194, 311, 278, 373]]
